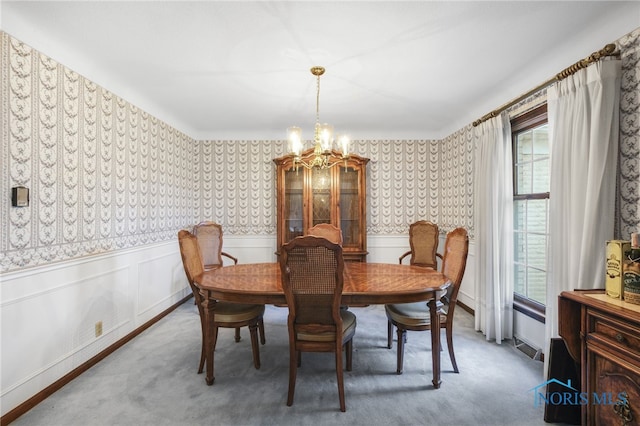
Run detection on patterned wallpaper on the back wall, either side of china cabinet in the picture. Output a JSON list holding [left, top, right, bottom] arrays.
[[196, 140, 439, 235]]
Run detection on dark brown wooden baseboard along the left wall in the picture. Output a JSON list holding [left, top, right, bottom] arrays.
[[0, 293, 193, 426]]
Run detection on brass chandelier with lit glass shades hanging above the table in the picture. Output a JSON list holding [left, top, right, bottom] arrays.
[[287, 66, 350, 169]]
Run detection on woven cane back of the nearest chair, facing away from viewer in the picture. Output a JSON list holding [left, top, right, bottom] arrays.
[[280, 235, 344, 332]]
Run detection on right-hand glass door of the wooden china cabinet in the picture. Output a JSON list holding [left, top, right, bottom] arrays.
[[340, 167, 361, 246]]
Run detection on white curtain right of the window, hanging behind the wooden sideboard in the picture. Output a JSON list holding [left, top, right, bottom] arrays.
[[545, 60, 621, 371]]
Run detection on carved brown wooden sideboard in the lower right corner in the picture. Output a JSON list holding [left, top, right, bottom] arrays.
[[558, 290, 640, 425]]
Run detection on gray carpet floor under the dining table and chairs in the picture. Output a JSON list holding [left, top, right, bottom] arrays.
[[13, 299, 546, 426]]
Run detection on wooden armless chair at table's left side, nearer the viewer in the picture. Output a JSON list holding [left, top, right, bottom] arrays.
[[178, 229, 266, 373]]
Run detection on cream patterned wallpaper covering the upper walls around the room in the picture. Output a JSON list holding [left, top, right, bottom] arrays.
[[0, 29, 640, 271]]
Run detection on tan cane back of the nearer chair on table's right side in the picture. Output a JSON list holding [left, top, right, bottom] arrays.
[[442, 228, 469, 307]]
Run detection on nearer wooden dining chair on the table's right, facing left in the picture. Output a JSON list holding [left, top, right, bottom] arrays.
[[385, 228, 469, 374]]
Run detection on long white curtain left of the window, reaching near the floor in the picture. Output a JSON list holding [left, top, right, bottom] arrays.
[[474, 112, 513, 343]]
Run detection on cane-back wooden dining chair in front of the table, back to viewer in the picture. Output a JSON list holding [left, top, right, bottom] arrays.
[[280, 235, 356, 412]]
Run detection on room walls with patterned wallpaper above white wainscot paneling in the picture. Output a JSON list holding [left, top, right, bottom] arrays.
[[0, 30, 640, 420]]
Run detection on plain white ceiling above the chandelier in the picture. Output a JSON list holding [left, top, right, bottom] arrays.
[[0, 0, 640, 140]]
